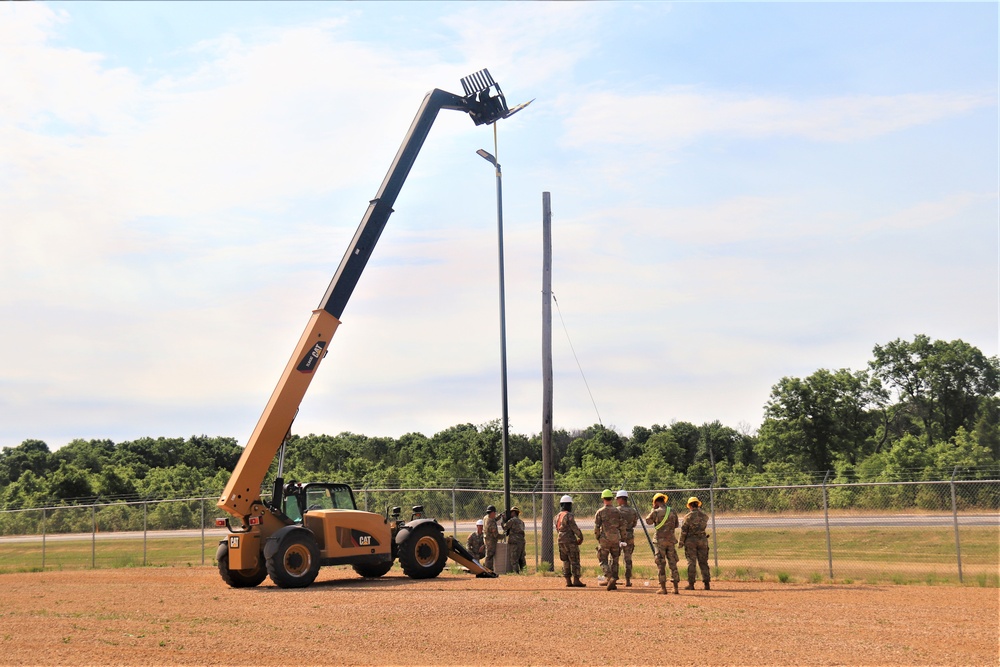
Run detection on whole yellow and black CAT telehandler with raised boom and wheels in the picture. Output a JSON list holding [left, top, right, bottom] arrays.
[[216, 69, 530, 588]]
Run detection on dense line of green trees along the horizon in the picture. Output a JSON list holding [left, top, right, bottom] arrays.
[[0, 335, 1000, 509]]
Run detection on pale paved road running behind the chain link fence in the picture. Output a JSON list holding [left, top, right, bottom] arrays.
[[0, 513, 1000, 545]]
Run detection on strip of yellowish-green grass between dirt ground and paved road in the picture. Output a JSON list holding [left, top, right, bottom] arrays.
[[0, 524, 1000, 588]]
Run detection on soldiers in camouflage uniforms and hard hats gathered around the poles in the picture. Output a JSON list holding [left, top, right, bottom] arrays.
[[468, 489, 712, 595]]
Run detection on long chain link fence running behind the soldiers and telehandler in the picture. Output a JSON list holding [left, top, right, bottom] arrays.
[[0, 480, 1000, 587]]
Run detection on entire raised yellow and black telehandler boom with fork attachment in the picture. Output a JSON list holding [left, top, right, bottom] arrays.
[[217, 69, 530, 536]]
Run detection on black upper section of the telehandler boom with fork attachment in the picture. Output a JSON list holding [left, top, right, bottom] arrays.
[[319, 70, 525, 320]]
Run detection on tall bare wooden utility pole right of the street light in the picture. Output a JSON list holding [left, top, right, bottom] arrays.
[[541, 192, 556, 570]]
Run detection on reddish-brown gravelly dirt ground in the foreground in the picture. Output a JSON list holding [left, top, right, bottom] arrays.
[[0, 567, 1000, 666]]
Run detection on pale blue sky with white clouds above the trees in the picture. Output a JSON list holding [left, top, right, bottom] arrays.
[[0, 1, 1000, 449]]
